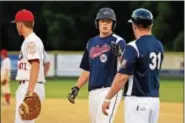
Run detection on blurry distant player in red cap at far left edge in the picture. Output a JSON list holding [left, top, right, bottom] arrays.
[[1, 49, 11, 105]]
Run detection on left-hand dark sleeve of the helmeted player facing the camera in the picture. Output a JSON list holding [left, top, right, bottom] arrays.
[[80, 48, 90, 71]]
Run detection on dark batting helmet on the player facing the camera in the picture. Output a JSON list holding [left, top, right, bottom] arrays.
[[95, 8, 116, 29]]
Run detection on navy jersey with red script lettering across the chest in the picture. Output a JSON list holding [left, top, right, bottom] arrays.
[[80, 34, 126, 91]]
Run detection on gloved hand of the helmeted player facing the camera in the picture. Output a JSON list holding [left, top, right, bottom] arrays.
[[67, 86, 80, 104]]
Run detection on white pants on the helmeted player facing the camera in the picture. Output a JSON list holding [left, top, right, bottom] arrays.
[[89, 87, 122, 123]]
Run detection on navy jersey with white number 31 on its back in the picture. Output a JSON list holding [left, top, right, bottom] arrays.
[[119, 35, 164, 97]]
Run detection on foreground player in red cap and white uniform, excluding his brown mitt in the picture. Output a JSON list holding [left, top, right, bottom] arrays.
[[13, 9, 48, 123]]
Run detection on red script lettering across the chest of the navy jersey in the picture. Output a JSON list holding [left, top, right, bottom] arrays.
[[90, 44, 111, 59]]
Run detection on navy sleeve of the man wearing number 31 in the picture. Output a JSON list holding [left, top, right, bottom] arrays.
[[118, 45, 138, 75]]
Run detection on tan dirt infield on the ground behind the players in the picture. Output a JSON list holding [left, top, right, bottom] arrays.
[[1, 99, 183, 123]]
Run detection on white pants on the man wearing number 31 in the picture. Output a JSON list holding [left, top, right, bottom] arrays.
[[124, 96, 160, 123]]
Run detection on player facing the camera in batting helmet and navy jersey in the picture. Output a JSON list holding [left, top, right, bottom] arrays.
[[68, 8, 126, 123]]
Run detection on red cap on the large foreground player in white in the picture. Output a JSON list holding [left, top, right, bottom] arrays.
[[11, 9, 34, 23]]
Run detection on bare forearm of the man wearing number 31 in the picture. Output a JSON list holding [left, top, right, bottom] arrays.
[[106, 73, 128, 99]]
